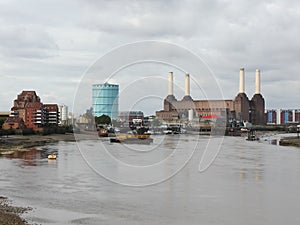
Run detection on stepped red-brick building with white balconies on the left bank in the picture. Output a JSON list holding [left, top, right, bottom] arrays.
[[2, 91, 59, 130]]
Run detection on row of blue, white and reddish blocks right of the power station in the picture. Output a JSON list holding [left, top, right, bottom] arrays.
[[267, 109, 300, 125]]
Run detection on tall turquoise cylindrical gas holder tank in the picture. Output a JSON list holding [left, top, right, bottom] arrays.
[[93, 83, 119, 119]]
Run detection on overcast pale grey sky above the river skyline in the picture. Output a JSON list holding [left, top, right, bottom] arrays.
[[0, 0, 300, 114]]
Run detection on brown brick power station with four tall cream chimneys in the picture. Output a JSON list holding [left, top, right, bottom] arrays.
[[156, 68, 266, 125]]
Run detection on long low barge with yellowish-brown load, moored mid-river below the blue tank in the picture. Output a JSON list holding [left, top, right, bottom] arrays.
[[110, 133, 153, 144]]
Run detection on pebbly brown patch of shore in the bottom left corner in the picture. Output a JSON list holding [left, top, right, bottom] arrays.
[[0, 196, 32, 225]]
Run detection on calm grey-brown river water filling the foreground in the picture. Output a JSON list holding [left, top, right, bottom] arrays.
[[0, 135, 300, 225]]
